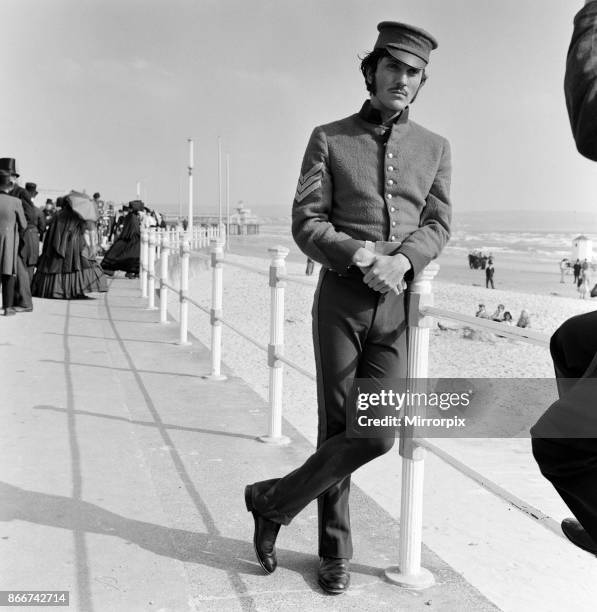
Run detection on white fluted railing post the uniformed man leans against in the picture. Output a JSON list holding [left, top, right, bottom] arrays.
[[385, 263, 439, 590]]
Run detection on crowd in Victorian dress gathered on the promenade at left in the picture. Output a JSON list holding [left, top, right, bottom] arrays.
[[0, 157, 165, 316]]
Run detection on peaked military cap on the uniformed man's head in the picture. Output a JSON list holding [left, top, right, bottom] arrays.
[[374, 21, 437, 68]]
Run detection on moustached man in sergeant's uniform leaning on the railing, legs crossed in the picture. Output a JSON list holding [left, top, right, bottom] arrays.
[[245, 21, 451, 594]]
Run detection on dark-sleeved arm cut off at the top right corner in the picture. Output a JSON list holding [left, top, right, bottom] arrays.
[[564, 0, 597, 161]]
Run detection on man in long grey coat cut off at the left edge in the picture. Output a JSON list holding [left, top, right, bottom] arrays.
[[0, 169, 27, 316]]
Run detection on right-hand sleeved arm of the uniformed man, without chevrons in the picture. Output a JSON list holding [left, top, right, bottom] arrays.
[[398, 139, 452, 279]]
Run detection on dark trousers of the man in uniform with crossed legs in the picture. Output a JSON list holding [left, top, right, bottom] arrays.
[[253, 269, 407, 559]]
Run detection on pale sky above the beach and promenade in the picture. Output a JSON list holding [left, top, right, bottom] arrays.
[[0, 0, 597, 220]]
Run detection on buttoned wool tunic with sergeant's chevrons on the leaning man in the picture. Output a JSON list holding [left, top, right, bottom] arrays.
[[292, 101, 451, 275]]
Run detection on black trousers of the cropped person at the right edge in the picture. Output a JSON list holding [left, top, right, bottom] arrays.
[[531, 312, 597, 542]]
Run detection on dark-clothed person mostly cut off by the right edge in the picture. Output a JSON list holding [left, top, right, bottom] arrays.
[[531, 0, 597, 554]]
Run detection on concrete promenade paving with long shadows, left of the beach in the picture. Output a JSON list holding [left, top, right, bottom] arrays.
[[0, 278, 497, 612]]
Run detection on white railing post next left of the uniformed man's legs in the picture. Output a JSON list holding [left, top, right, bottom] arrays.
[[258, 246, 290, 444]]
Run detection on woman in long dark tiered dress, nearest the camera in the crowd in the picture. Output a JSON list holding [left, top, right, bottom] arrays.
[[31, 193, 108, 300]]
